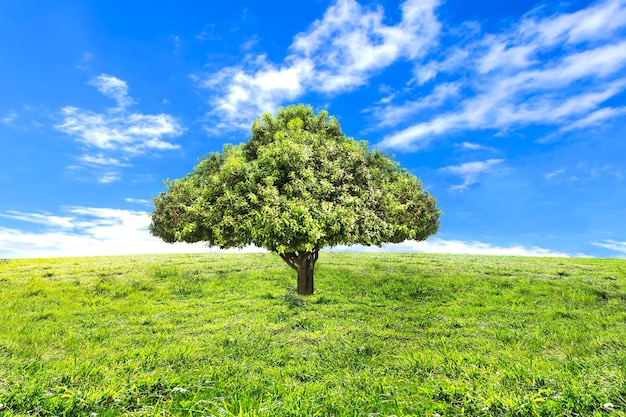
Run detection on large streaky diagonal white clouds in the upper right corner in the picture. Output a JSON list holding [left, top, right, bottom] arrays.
[[379, 0, 626, 149]]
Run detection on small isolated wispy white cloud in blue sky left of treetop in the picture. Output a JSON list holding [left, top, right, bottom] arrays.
[[55, 74, 184, 183]]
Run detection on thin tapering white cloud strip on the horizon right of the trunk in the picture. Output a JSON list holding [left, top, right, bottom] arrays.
[[330, 238, 585, 257]]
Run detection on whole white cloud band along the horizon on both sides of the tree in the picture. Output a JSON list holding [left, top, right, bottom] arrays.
[[0, 206, 584, 258]]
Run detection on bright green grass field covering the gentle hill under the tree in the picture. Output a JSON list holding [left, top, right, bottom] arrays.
[[0, 253, 626, 417]]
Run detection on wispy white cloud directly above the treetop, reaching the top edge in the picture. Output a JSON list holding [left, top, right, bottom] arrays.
[[194, 0, 439, 130]]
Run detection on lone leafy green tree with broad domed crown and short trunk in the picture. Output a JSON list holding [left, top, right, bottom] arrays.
[[150, 105, 440, 295]]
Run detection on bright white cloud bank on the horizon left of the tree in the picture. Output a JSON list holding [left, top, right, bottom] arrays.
[[0, 207, 261, 258]]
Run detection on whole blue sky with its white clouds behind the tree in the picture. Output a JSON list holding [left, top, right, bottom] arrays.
[[0, 0, 626, 258]]
